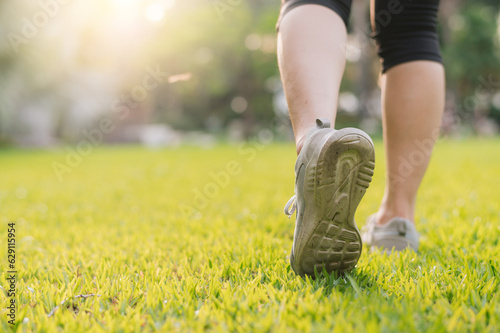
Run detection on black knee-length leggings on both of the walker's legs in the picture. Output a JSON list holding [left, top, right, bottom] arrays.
[[278, 0, 442, 72]]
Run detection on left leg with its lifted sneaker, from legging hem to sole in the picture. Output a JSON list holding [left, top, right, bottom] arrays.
[[278, 0, 375, 275]]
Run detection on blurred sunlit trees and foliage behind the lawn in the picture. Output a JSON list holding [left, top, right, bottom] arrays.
[[0, 0, 500, 146]]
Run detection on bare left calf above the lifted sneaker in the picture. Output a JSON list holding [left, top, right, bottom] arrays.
[[278, 4, 347, 153]]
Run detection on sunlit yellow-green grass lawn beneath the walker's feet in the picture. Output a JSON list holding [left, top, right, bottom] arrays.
[[0, 139, 500, 332]]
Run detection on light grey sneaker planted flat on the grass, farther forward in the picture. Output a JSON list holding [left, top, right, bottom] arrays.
[[361, 214, 420, 252]]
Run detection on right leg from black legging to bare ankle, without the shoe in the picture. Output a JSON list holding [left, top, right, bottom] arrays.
[[371, 0, 445, 224]]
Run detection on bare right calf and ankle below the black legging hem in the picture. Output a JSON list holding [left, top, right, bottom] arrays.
[[377, 61, 445, 224]]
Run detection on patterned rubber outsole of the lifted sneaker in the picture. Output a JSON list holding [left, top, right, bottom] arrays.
[[292, 128, 375, 275]]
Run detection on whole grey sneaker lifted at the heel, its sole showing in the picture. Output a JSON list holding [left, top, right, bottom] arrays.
[[285, 119, 375, 276]]
